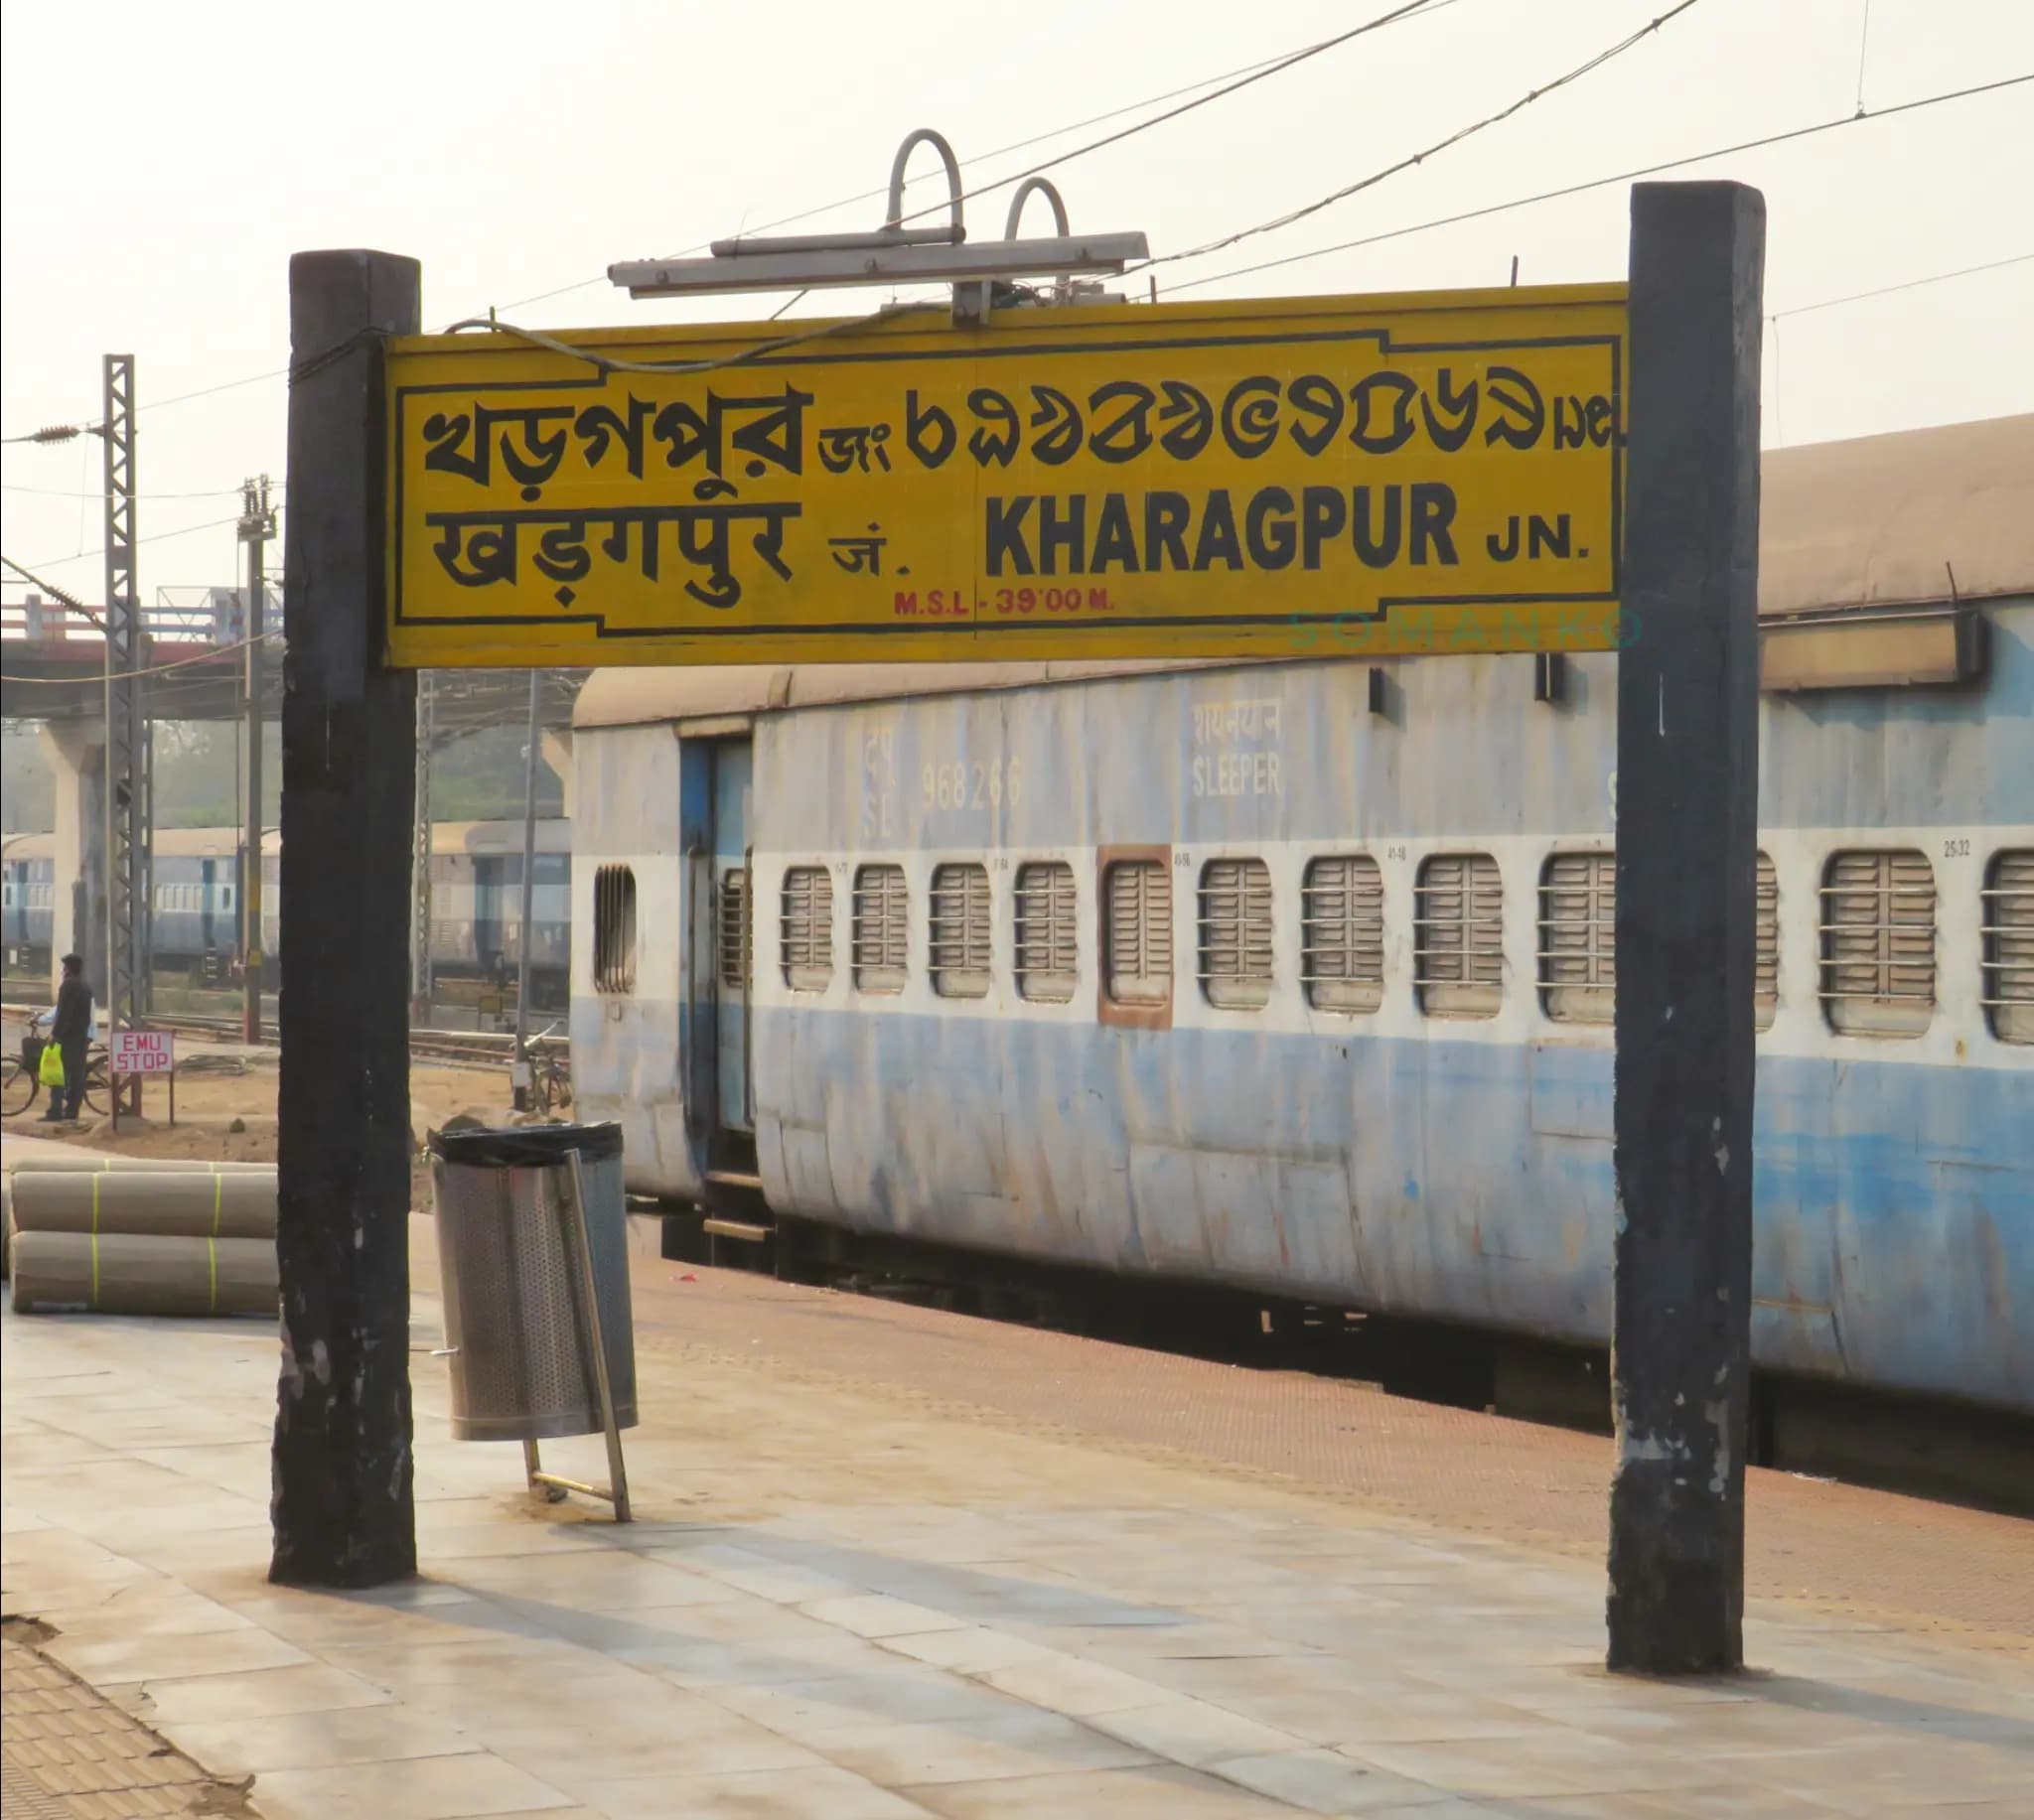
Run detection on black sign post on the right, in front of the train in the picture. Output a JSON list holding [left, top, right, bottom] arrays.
[[1609, 183, 1766, 1674]]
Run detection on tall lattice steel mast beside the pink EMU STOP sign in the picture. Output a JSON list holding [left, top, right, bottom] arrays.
[[99, 353, 151, 1120]]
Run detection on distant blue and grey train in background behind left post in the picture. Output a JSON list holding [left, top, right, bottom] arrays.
[[0, 819, 571, 999]]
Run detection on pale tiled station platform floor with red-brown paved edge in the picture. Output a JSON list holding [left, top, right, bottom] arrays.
[[0, 1179, 2034, 1820]]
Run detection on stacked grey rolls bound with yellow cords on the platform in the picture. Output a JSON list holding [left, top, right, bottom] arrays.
[[6, 1153, 279, 1316]]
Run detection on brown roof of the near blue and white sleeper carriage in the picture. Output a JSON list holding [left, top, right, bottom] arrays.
[[574, 413, 2034, 726]]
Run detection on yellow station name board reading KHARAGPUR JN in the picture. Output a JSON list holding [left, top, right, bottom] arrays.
[[386, 285, 1625, 667]]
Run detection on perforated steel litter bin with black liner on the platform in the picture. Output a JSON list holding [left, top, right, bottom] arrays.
[[431, 1125, 637, 1442]]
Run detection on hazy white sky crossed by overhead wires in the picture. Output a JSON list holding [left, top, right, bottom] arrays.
[[0, 0, 2034, 600]]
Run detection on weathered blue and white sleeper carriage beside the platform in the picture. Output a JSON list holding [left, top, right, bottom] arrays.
[[571, 417, 2034, 1411]]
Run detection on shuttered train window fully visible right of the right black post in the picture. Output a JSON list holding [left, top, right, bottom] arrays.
[[1822, 848, 1935, 1038]]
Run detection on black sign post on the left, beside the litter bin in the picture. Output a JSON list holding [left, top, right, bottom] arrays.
[[270, 252, 421, 1586]]
